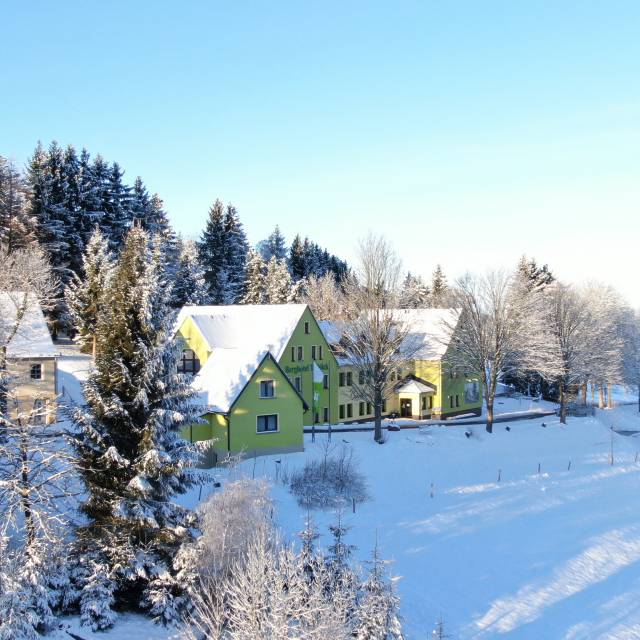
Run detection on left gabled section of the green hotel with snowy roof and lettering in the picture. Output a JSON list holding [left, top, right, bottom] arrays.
[[172, 304, 339, 463]]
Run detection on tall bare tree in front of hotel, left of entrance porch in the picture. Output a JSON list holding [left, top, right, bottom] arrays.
[[340, 235, 415, 442]]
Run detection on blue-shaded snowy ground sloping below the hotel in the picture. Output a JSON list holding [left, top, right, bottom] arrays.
[[51, 352, 640, 640]]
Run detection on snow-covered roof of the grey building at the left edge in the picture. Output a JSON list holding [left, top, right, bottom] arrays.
[[0, 291, 58, 358]]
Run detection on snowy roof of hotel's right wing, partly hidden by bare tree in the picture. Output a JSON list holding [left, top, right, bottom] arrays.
[[318, 309, 460, 364]]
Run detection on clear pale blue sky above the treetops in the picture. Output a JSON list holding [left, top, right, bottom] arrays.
[[0, 0, 640, 305]]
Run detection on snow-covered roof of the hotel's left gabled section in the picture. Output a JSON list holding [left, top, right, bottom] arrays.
[[177, 304, 306, 413]]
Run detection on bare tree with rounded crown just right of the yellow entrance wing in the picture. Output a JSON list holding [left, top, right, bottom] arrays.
[[443, 271, 526, 433]]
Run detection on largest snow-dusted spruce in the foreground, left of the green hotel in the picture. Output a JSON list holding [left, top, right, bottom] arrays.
[[73, 228, 199, 628]]
